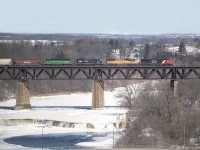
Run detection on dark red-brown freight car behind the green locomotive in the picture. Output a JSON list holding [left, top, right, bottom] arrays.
[[12, 59, 41, 65]]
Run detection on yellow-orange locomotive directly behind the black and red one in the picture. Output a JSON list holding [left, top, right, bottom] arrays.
[[106, 59, 140, 65]]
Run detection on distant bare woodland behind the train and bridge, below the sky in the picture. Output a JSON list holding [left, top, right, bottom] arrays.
[[0, 35, 200, 99]]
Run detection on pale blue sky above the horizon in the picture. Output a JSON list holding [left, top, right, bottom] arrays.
[[0, 0, 200, 34]]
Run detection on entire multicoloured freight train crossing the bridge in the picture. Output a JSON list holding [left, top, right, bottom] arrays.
[[0, 58, 173, 66]]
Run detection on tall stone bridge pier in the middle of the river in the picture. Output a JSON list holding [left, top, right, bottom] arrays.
[[92, 80, 104, 109]]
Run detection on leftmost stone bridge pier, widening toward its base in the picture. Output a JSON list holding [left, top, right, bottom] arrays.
[[15, 81, 31, 110]]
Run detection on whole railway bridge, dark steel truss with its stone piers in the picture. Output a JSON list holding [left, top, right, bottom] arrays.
[[0, 65, 200, 109]]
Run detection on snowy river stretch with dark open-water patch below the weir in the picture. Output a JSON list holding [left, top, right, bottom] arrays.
[[0, 125, 112, 149]]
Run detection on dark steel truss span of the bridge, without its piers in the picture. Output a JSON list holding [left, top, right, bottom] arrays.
[[0, 65, 200, 80]]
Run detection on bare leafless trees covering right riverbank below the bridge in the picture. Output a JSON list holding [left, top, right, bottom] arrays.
[[116, 79, 200, 149]]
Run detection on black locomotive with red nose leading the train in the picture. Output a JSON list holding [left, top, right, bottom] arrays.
[[140, 59, 173, 65]]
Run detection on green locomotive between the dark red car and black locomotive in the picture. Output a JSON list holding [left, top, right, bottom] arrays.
[[42, 59, 72, 65]]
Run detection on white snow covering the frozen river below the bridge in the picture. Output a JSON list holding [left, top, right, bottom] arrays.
[[0, 91, 127, 149]]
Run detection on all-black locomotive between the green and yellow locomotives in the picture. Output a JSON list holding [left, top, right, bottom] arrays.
[[76, 58, 103, 65]]
